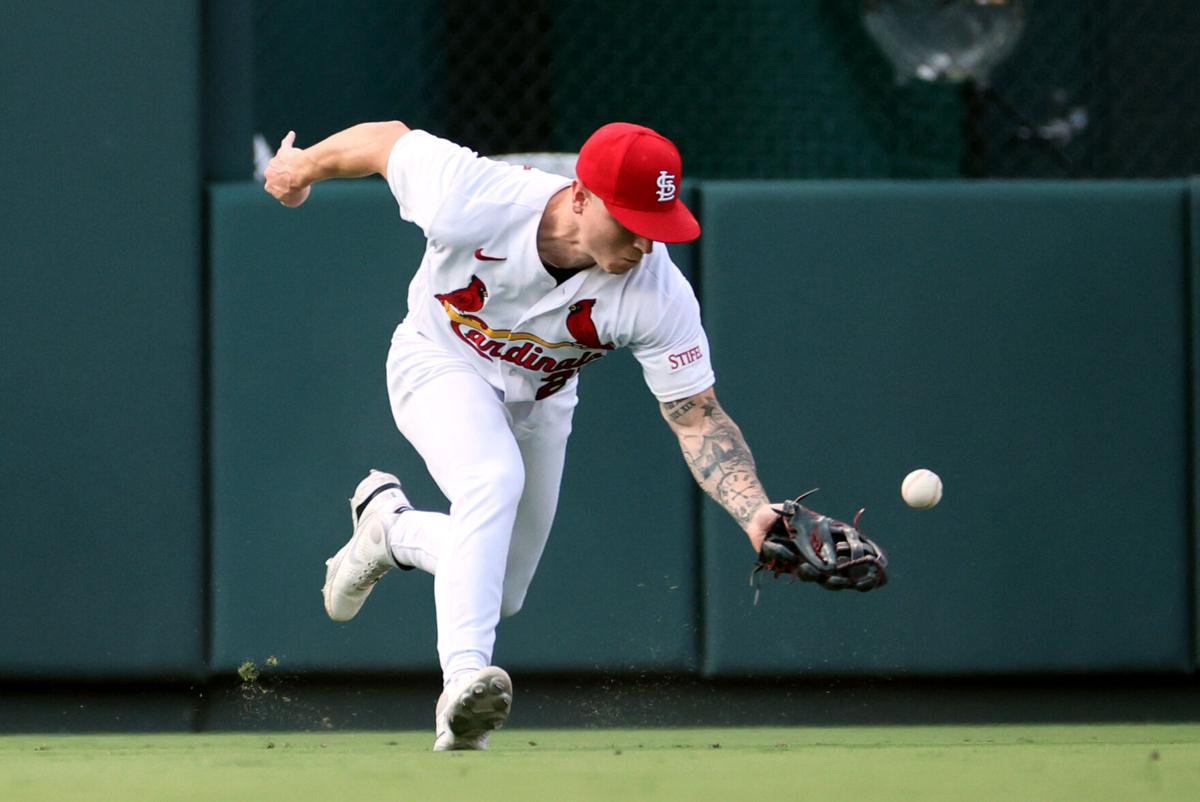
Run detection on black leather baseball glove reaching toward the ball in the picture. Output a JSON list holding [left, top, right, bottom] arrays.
[[750, 490, 888, 595]]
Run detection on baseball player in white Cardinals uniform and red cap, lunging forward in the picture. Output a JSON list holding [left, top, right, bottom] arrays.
[[265, 121, 854, 750]]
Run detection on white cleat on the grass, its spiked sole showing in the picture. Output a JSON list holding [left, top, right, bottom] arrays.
[[433, 665, 512, 752]]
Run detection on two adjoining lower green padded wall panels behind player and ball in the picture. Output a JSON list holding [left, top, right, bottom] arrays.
[[201, 181, 1195, 677]]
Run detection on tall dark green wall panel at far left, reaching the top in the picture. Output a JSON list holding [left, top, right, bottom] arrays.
[[0, 0, 208, 678]]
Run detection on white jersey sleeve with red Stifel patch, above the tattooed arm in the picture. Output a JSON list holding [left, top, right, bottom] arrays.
[[629, 286, 715, 402]]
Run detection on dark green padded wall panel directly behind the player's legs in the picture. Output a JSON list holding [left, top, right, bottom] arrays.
[[211, 180, 697, 671]]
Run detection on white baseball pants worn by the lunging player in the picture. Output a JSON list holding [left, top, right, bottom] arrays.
[[388, 327, 577, 682]]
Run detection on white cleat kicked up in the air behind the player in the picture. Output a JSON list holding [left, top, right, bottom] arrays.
[[322, 469, 412, 621]]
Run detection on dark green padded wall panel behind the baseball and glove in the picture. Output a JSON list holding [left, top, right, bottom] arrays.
[[701, 181, 1193, 675]]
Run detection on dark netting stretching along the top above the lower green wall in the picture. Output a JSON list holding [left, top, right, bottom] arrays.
[[254, 0, 1200, 178]]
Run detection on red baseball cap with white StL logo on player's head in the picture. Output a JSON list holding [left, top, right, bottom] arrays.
[[575, 122, 700, 243]]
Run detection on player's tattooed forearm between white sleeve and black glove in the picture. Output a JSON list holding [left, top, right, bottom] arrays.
[[664, 397, 768, 526]]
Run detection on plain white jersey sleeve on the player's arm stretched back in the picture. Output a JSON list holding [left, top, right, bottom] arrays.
[[388, 131, 482, 237]]
